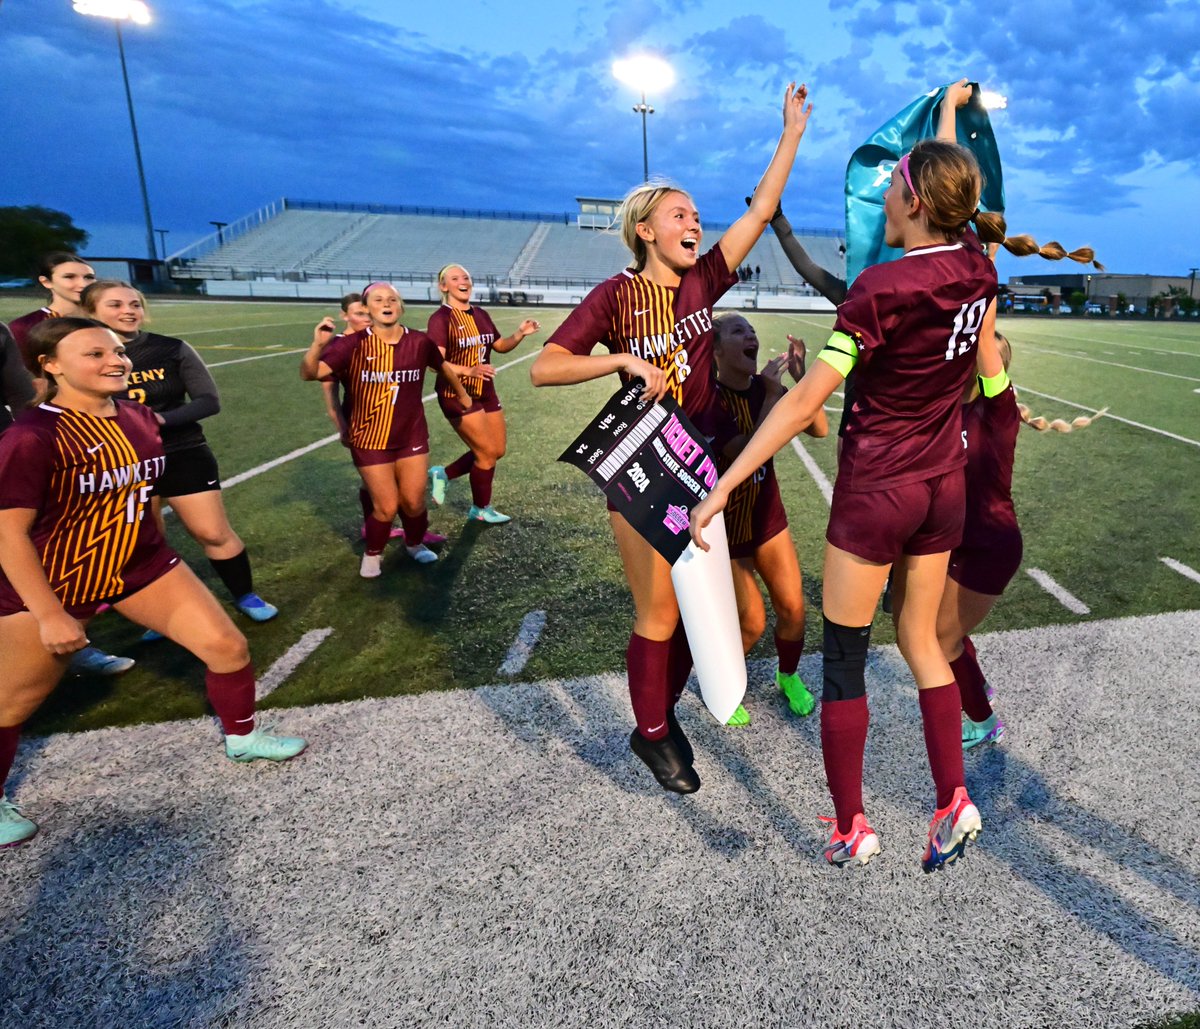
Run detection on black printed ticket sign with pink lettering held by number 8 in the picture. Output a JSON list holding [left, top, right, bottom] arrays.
[[558, 384, 718, 565]]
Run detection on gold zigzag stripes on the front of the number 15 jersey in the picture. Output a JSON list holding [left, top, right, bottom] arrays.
[[42, 411, 149, 604]]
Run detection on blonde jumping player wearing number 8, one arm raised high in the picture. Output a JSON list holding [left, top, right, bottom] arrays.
[[530, 83, 812, 793]]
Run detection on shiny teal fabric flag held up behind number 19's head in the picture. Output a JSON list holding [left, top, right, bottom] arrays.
[[846, 83, 1004, 284]]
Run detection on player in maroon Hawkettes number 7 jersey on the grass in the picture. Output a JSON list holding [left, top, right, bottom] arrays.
[[300, 282, 475, 579]]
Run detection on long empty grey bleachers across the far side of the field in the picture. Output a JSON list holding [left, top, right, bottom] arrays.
[[169, 200, 845, 307]]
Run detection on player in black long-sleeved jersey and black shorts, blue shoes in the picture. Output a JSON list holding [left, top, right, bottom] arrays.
[[79, 278, 280, 623]]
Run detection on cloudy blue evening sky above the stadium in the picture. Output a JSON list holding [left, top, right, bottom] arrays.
[[0, 0, 1200, 276]]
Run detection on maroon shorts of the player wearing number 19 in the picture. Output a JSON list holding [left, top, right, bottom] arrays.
[[826, 468, 966, 565]]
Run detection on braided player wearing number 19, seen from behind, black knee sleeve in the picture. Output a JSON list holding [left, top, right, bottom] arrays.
[[691, 139, 1090, 871]]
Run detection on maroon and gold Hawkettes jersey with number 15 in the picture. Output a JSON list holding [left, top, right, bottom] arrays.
[[0, 401, 172, 610]]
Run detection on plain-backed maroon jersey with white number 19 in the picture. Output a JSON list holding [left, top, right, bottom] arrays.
[[834, 233, 996, 492]]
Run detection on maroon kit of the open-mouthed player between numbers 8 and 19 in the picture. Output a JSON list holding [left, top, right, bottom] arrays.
[[713, 375, 787, 558]]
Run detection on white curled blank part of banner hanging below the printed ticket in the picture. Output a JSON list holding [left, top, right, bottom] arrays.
[[671, 512, 746, 726]]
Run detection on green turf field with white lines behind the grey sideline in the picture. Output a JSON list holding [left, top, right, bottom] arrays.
[[0, 297, 1200, 734]]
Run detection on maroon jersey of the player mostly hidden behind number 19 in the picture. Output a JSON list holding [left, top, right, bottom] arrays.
[[962, 383, 1021, 547]]
